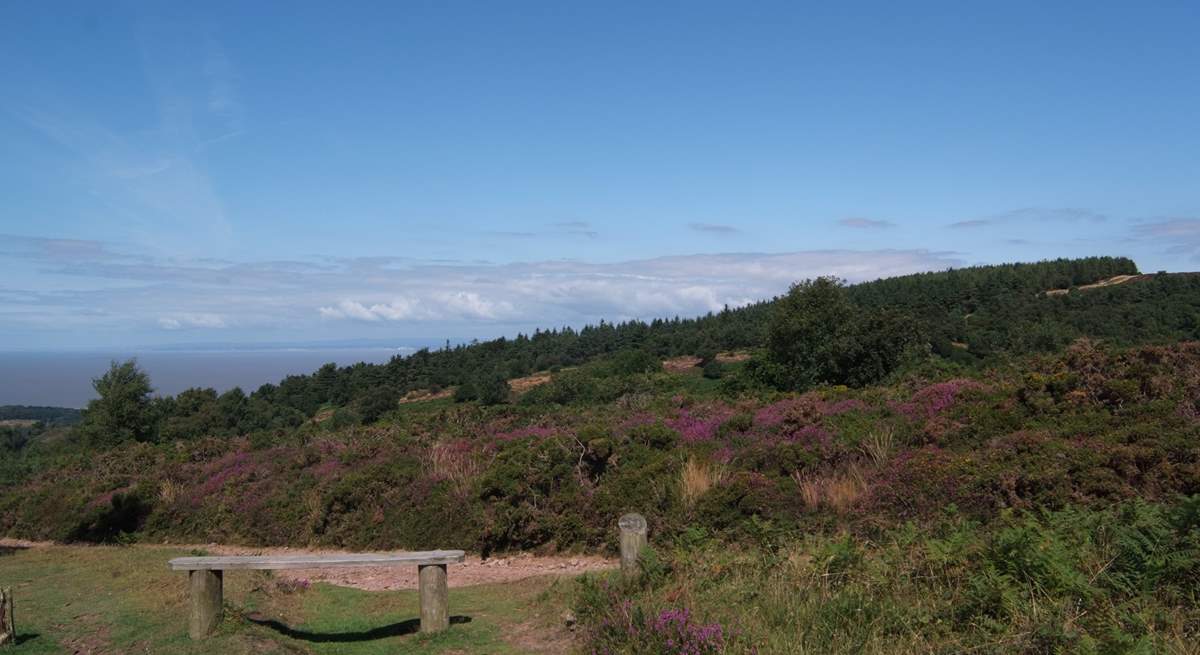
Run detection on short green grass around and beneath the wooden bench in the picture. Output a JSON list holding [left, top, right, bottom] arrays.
[[0, 546, 570, 655]]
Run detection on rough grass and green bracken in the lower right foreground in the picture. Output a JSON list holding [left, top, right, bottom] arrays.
[[575, 495, 1200, 655]]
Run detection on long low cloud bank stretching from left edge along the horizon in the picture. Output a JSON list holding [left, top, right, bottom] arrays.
[[0, 236, 962, 345]]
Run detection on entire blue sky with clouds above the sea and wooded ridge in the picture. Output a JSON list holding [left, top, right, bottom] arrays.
[[0, 1, 1200, 349]]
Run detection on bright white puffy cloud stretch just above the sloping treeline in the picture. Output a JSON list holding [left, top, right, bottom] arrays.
[[318, 251, 961, 324]]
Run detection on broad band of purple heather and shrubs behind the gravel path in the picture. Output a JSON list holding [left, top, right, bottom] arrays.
[[0, 347, 1200, 549]]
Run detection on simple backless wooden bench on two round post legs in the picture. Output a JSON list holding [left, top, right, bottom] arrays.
[[169, 551, 464, 639]]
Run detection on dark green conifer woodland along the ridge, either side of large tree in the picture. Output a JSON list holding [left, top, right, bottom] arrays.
[[65, 258, 1200, 439]]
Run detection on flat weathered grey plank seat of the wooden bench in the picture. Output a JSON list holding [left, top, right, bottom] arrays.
[[168, 551, 466, 571]]
